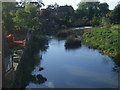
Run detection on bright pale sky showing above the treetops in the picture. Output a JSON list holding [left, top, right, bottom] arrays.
[[17, 0, 120, 10]]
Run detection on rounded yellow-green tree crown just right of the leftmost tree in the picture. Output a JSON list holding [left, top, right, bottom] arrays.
[[13, 3, 41, 30]]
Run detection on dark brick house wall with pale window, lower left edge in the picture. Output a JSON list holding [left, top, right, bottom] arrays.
[[2, 37, 14, 88]]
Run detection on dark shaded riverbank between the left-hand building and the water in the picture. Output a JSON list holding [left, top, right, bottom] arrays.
[[13, 33, 48, 88]]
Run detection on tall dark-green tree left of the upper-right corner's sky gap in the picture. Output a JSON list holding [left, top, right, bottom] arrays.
[[76, 1, 100, 23]]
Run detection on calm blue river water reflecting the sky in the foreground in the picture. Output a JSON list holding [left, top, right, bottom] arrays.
[[26, 39, 118, 88]]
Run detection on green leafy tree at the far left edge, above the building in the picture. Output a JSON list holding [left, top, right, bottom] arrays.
[[2, 2, 16, 33]]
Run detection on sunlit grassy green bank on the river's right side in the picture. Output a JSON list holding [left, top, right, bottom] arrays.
[[83, 26, 120, 65]]
